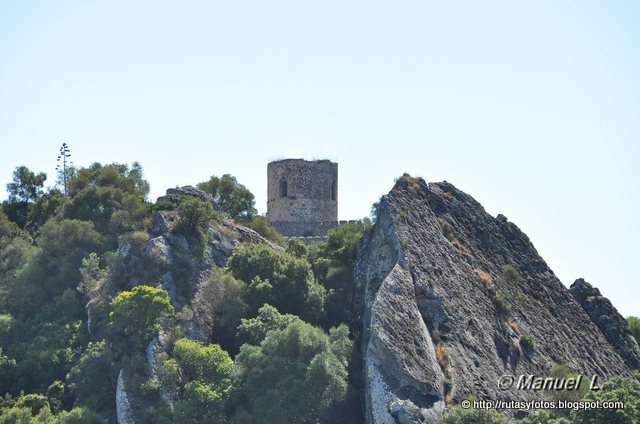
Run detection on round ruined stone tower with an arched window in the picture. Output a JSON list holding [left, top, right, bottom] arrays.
[[267, 159, 338, 237]]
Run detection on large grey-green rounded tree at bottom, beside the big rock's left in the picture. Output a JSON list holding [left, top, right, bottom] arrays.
[[236, 319, 350, 424]]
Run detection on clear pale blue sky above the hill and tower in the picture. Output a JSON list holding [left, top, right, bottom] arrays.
[[0, 0, 640, 315]]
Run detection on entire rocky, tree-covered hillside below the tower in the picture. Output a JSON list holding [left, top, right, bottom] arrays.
[[0, 163, 640, 424]]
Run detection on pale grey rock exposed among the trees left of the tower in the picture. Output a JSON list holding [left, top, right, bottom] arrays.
[[114, 186, 284, 424]]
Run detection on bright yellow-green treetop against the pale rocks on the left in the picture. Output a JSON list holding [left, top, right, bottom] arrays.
[[109, 286, 174, 351]]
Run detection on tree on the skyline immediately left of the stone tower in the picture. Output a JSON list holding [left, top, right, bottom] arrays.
[[197, 174, 256, 219]]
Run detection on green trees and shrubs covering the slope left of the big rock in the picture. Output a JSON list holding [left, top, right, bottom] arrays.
[[0, 163, 370, 423]]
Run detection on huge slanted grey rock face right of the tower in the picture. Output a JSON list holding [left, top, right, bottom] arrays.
[[355, 175, 637, 424]]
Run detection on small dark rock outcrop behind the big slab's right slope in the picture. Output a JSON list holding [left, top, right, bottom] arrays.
[[569, 278, 640, 369]]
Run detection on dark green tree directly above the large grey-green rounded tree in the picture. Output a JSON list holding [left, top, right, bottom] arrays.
[[229, 244, 326, 322]]
